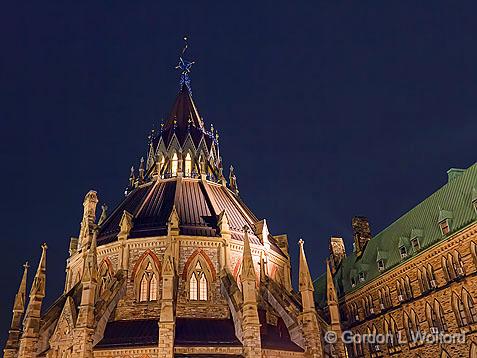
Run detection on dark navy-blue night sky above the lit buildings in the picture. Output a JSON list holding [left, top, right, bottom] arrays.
[[0, 0, 477, 345]]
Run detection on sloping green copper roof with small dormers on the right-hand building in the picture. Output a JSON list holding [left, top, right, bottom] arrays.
[[315, 163, 477, 306]]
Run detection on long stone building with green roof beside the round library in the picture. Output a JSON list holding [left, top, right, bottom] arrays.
[[315, 164, 477, 358]]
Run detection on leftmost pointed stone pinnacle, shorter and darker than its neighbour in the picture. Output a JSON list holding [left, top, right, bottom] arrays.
[[3, 262, 29, 358]]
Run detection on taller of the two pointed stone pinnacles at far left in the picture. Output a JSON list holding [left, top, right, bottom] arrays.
[[18, 244, 48, 358]]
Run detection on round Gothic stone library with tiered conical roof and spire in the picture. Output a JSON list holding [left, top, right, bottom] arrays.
[[4, 49, 327, 358]]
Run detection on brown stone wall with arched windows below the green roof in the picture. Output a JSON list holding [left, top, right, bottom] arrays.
[[340, 224, 477, 358]]
